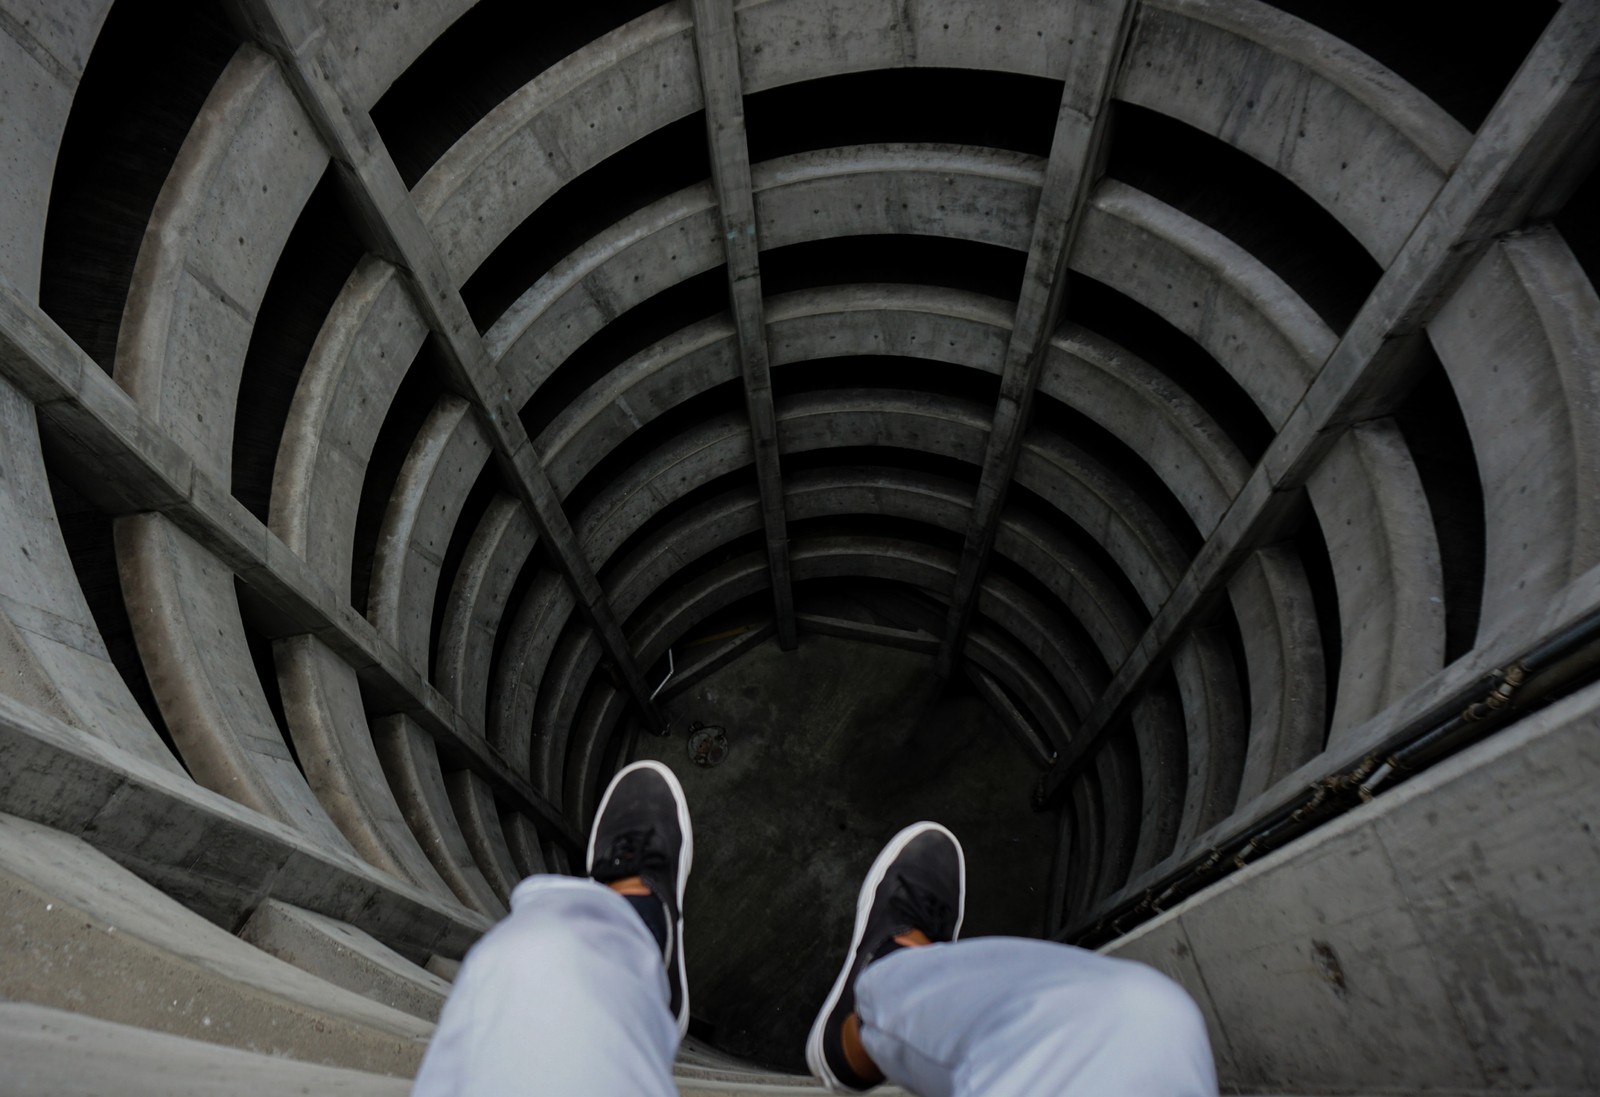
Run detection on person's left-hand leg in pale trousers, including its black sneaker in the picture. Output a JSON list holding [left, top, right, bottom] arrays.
[[411, 761, 694, 1097]]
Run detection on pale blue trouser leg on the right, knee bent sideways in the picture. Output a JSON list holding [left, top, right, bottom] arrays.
[[856, 937, 1216, 1097]]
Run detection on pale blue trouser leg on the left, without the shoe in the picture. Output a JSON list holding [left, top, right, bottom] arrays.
[[411, 876, 678, 1097]]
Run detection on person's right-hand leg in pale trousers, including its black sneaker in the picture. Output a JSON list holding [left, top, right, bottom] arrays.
[[806, 824, 1216, 1097]]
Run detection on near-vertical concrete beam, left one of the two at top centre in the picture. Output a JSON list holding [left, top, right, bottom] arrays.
[[693, 0, 795, 651]]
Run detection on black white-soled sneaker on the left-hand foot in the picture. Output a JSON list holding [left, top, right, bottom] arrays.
[[587, 761, 694, 1038]]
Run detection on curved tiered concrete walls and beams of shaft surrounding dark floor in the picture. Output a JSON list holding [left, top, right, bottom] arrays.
[[0, 0, 1600, 1093]]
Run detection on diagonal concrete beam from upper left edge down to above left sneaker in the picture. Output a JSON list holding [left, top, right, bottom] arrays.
[[234, 0, 664, 729]]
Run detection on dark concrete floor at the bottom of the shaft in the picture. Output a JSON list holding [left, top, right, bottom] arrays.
[[632, 636, 1054, 1073]]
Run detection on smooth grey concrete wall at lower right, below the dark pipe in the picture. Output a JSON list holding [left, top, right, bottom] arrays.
[[1106, 686, 1600, 1095]]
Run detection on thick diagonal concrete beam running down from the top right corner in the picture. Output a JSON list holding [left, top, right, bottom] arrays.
[[1038, 0, 1600, 806]]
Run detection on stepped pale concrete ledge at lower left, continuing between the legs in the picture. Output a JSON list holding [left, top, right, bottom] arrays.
[[0, 802, 818, 1097]]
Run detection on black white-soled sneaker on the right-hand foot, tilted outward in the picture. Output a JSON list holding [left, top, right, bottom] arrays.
[[805, 822, 966, 1094]]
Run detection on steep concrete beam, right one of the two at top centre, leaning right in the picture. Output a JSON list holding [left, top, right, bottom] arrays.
[[934, 0, 1134, 681]]
